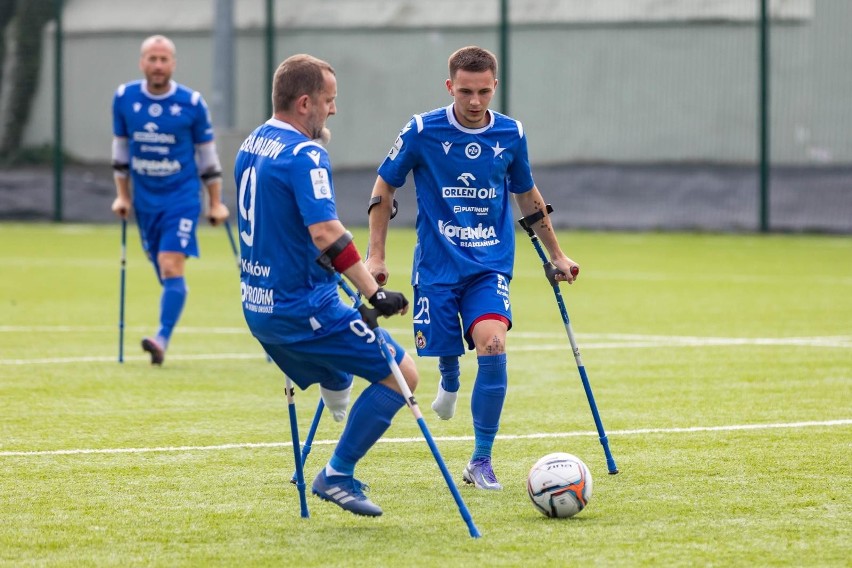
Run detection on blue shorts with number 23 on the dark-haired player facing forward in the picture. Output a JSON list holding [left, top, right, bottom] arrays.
[[412, 272, 512, 357]]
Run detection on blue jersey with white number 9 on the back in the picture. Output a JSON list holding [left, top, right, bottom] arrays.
[[234, 118, 352, 344]]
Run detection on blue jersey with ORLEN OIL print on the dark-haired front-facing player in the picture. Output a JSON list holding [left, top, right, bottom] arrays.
[[378, 105, 535, 285]]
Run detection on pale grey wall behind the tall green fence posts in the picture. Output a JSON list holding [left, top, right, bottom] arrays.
[[25, 0, 852, 178]]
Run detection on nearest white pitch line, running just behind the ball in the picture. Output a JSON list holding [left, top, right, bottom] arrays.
[[0, 418, 852, 458]]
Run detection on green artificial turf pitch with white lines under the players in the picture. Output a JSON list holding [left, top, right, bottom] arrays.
[[0, 224, 852, 567]]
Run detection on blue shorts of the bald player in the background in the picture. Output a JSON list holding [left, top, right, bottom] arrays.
[[136, 203, 201, 264]]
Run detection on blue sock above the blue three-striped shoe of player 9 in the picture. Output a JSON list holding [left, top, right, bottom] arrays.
[[328, 383, 405, 475]]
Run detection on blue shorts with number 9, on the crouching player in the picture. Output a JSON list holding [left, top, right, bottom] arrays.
[[260, 310, 405, 390]]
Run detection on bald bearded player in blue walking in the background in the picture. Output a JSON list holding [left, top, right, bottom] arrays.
[[112, 35, 229, 365]]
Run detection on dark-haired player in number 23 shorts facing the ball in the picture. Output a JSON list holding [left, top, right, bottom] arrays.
[[366, 46, 577, 489]]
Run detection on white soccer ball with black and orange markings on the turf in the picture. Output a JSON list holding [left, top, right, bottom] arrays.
[[527, 452, 592, 519]]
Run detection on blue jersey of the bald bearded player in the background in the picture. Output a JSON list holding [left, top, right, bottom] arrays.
[[112, 81, 213, 212]]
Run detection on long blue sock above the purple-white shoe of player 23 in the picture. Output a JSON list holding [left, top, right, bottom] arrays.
[[470, 353, 508, 460]]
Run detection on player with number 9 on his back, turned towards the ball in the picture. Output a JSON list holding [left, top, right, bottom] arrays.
[[234, 54, 418, 516]]
